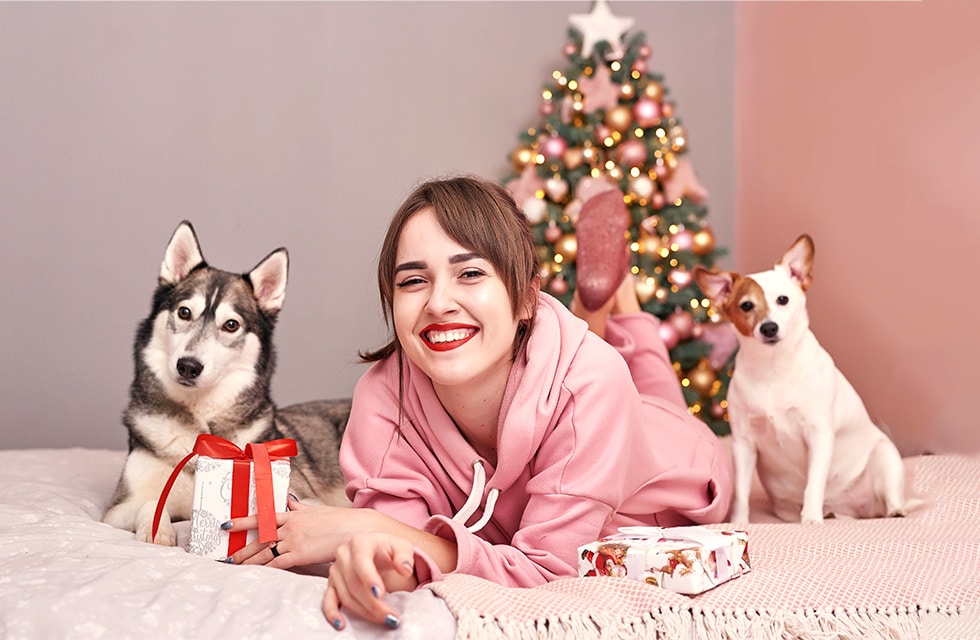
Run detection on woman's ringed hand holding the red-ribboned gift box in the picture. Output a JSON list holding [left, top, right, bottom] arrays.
[[222, 495, 378, 569]]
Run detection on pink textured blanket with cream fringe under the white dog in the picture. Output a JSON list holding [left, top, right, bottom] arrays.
[[428, 455, 980, 640]]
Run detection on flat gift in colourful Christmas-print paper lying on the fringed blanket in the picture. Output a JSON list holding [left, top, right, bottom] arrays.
[[578, 527, 750, 595]]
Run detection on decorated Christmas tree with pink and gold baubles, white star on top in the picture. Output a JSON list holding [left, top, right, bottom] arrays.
[[504, 0, 736, 434]]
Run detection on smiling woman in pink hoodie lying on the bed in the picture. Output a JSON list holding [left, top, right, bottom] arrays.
[[226, 177, 731, 628]]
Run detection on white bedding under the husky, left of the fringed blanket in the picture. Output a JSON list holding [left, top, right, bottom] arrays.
[[0, 449, 456, 640]]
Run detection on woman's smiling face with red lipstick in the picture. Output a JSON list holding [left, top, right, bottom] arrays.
[[392, 208, 520, 396]]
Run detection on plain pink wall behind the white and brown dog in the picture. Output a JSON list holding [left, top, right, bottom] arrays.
[[735, 0, 980, 454]]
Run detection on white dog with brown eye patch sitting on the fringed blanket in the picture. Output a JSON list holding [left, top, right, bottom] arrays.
[[694, 235, 907, 523]]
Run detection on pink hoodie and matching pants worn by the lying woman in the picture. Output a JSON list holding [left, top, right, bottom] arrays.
[[340, 294, 732, 587]]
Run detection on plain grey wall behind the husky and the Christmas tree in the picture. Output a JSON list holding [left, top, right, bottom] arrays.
[[0, 2, 735, 448]]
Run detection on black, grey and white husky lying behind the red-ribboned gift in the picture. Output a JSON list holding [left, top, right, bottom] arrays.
[[103, 221, 350, 545]]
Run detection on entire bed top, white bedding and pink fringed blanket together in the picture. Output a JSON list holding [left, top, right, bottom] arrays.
[[0, 449, 980, 640]]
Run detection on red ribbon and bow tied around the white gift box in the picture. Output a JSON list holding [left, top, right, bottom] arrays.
[[150, 433, 297, 555]]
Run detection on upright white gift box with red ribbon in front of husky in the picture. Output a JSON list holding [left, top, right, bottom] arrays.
[[152, 434, 296, 560]]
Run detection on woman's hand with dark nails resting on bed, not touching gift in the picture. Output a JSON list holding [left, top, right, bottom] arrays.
[[323, 532, 418, 629]]
